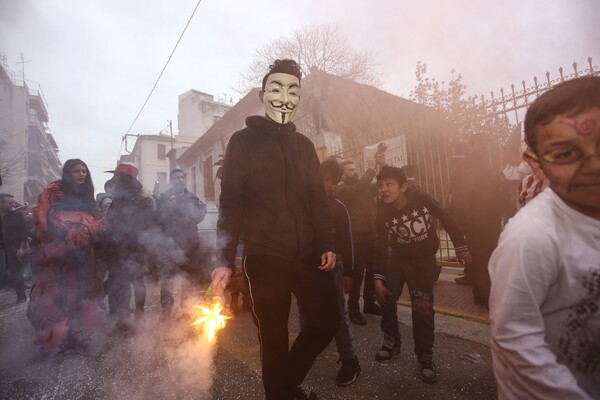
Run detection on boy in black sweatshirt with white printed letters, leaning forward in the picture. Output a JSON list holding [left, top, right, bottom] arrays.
[[373, 166, 471, 382]]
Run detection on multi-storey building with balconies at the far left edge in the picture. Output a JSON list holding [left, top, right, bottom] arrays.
[[0, 58, 61, 204]]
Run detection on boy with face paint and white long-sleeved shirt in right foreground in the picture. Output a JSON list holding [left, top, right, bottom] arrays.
[[489, 77, 600, 399]]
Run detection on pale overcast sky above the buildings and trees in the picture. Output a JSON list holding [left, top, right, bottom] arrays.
[[0, 0, 600, 191]]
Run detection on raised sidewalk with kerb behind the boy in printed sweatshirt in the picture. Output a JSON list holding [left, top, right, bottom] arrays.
[[398, 267, 490, 324]]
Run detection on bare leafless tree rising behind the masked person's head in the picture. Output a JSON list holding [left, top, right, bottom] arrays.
[[234, 25, 381, 95]]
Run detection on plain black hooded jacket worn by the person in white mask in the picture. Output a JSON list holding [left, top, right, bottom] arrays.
[[217, 116, 334, 268]]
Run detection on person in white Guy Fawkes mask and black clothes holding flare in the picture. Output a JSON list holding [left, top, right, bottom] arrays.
[[212, 60, 340, 400]]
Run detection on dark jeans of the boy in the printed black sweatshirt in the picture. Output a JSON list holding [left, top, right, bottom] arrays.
[[381, 255, 437, 358]]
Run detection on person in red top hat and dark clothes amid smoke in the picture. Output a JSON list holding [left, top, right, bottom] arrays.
[[102, 164, 155, 336]]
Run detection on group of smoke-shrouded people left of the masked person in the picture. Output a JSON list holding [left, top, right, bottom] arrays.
[[0, 159, 206, 358]]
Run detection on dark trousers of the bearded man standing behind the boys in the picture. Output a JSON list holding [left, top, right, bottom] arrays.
[[348, 242, 375, 312]]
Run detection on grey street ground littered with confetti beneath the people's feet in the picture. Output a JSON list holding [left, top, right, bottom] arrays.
[[0, 268, 496, 400]]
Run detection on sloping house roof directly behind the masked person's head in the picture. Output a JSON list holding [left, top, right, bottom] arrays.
[[178, 71, 437, 164]]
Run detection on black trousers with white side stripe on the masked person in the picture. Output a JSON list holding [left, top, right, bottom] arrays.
[[243, 255, 340, 400]]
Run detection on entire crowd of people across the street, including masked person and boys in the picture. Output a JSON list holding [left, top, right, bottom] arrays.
[[0, 60, 600, 400]]
